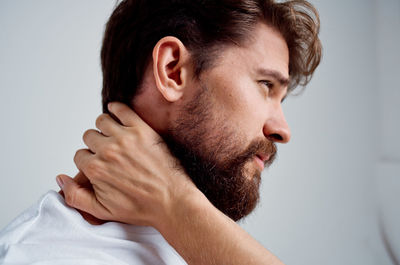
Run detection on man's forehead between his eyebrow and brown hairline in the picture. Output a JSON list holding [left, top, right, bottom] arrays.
[[217, 23, 289, 78]]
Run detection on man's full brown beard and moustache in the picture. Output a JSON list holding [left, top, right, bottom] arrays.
[[162, 85, 276, 221]]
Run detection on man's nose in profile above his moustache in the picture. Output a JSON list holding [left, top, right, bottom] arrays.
[[263, 104, 290, 143]]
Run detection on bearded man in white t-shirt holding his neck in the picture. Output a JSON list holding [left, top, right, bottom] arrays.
[[0, 0, 321, 264]]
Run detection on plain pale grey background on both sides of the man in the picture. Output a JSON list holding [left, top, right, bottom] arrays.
[[0, 0, 400, 265]]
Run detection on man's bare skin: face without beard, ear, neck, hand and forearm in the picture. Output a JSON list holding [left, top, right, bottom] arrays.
[[57, 23, 290, 264]]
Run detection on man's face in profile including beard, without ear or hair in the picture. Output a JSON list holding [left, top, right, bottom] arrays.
[[163, 23, 290, 221]]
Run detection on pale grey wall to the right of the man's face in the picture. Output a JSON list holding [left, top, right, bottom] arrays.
[[244, 0, 400, 264]]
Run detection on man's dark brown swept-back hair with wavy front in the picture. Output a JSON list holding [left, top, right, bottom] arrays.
[[101, 0, 321, 112]]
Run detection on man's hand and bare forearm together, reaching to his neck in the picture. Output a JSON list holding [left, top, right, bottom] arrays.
[[57, 103, 283, 264]]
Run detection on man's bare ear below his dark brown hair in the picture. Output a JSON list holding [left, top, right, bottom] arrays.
[[153, 37, 190, 102]]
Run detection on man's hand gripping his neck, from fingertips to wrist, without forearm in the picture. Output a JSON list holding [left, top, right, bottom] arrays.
[[57, 103, 202, 228]]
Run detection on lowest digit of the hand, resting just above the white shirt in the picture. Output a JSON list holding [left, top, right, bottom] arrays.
[[56, 175, 111, 220]]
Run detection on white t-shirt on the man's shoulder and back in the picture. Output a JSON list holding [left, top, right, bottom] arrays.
[[0, 191, 186, 265]]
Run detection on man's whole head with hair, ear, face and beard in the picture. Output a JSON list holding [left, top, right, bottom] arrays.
[[101, 0, 321, 220]]
